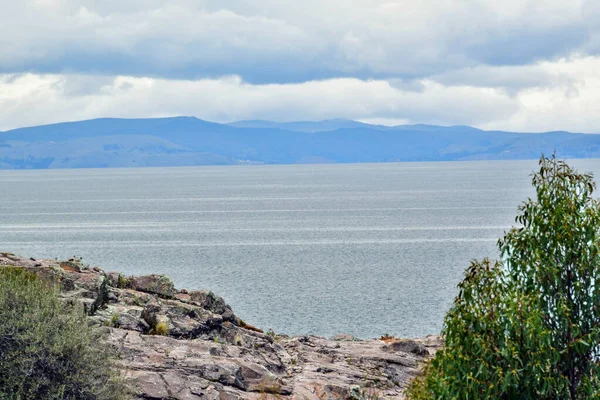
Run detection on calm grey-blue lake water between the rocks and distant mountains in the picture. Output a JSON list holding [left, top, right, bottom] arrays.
[[0, 160, 600, 338]]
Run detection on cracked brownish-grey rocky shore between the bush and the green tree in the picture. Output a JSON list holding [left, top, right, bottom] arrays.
[[0, 252, 441, 400]]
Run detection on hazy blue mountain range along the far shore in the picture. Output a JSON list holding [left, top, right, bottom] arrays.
[[0, 117, 600, 169]]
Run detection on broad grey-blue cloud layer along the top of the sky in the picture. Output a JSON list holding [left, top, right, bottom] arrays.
[[0, 0, 600, 83]]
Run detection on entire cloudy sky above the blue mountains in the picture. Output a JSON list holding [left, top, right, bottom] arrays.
[[0, 0, 600, 133]]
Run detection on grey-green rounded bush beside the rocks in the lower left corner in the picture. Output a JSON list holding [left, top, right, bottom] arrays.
[[0, 267, 127, 400]]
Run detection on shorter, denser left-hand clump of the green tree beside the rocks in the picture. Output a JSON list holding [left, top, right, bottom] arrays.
[[409, 259, 552, 399]]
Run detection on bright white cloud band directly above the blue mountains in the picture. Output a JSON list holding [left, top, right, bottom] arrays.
[[0, 56, 600, 132]]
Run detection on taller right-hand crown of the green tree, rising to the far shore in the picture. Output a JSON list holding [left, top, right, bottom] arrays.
[[499, 158, 600, 399]]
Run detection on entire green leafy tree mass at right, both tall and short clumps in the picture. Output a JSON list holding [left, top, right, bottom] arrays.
[[407, 157, 600, 399]]
